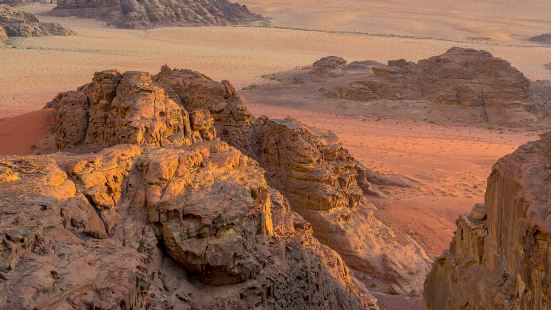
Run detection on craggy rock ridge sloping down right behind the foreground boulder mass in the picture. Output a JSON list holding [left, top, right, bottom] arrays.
[[250, 118, 429, 295]]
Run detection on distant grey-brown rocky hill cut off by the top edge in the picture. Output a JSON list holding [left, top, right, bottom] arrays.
[[51, 0, 264, 28]]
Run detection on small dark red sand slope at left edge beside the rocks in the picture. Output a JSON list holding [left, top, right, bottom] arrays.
[[0, 109, 54, 155]]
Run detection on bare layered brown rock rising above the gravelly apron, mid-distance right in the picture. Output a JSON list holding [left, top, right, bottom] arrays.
[[310, 47, 530, 106]]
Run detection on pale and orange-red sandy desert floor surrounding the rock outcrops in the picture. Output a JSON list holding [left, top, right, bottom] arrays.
[[0, 0, 551, 308]]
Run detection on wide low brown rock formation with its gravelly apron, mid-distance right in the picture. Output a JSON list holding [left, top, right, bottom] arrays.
[[245, 47, 549, 127]]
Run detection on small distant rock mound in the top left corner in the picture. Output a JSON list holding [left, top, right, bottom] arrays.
[[0, 5, 73, 39]]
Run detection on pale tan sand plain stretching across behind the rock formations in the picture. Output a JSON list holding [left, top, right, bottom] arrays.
[[0, 0, 551, 117]]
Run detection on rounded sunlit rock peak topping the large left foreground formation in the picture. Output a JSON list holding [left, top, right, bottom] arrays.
[[48, 71, 216, 150]]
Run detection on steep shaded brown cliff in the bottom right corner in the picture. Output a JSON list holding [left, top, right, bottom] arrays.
[[425, 134, 551, 309]]
